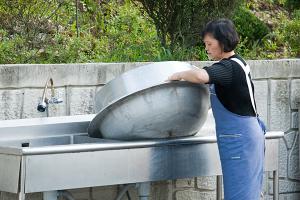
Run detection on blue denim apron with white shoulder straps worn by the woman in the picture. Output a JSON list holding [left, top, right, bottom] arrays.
[[210, 58, 265, 200]]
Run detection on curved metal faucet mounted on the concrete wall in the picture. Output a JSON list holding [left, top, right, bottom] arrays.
[[37, 78, 63, 112]]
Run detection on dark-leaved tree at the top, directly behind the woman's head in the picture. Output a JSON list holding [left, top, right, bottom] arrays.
[[132, 0, 243, 50]]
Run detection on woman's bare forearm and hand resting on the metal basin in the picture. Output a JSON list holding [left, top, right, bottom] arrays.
[[168, 68, 209, 83]]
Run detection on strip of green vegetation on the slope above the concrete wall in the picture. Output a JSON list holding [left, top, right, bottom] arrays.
[[0, 0, 300, 63]]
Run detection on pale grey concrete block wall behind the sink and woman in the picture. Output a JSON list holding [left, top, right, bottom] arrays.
[[0, 59, 300, 200]]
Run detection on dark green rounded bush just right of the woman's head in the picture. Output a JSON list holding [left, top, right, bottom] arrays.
[[233, 7, 269, 44]]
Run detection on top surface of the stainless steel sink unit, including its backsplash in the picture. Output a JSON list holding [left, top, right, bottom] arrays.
[[0, 110, 284, 156]]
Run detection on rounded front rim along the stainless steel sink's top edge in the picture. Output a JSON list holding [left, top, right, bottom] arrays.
[[0, 131, 283, 155]]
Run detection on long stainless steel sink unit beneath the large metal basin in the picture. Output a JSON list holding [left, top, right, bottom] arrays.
[[0, 115, 283, 200]]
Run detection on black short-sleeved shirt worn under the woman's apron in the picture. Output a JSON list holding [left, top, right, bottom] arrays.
[[203, 55, 256, 116]]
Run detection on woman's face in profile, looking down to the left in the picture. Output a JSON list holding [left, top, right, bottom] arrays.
[[203, 34, 223, 60]]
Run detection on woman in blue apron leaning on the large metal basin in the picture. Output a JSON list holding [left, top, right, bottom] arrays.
[[169, 19, 265, 200]]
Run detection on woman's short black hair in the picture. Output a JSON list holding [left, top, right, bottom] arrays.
[[202, 19, 240, 52]]
